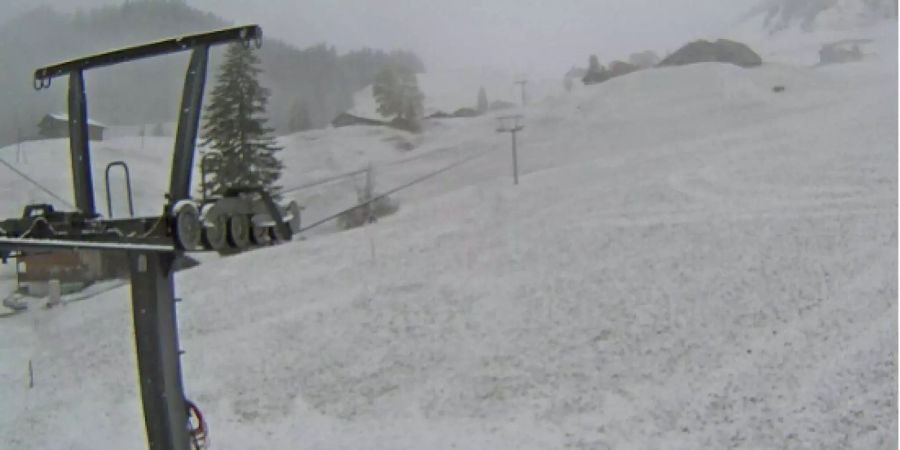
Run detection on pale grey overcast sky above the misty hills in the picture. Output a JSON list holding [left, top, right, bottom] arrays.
[[3, 0, 758, 77]]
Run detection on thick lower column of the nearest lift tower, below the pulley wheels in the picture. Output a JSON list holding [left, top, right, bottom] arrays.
[[128, 252, 190, 450]]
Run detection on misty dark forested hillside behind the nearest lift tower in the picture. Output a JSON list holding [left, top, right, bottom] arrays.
[[0, 0, 425, 145]]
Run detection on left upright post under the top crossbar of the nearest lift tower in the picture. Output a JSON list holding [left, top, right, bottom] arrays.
[[69, 70, 97, 217]]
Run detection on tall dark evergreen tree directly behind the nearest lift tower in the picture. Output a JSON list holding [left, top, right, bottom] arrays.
[[202, 44, 283, 195]]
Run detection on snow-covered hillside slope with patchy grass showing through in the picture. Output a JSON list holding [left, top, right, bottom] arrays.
[[0, 23, 898, 449]]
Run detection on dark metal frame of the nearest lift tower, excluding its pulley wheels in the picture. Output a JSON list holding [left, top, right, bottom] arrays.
[[9, 25, 264, 450]]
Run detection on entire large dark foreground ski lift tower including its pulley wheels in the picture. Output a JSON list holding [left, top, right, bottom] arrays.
[[0, 25, 300, 450]]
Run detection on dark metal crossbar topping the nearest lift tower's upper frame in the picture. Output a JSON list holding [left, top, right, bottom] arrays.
[[34, 25, 262, 83]]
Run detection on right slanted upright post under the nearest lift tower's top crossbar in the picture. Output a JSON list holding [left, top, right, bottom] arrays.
[[169, 46, 209, 208]]
